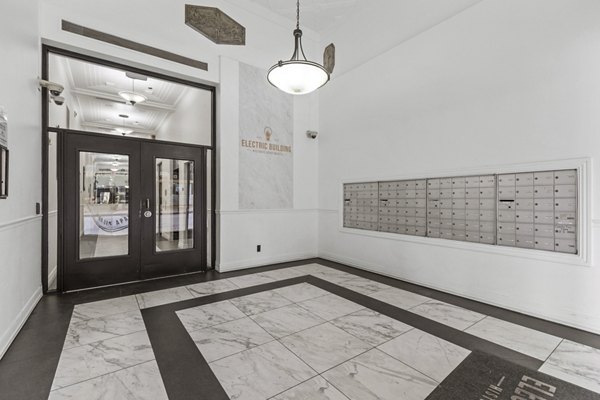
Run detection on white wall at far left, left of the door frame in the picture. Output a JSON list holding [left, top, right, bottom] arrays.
[[0, 0, 42, 357]]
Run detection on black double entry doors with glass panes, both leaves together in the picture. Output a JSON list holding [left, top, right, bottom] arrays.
[[60, 132, 207, 291]]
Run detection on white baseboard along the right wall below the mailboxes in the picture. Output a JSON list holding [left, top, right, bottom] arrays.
[[318, 252, 600, 334]]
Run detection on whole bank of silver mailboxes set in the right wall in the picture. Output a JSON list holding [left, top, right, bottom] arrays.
[[343, 169, 578, 253]]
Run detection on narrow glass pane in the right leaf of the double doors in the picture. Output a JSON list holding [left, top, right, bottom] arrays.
[[155, 158, 194, 253]]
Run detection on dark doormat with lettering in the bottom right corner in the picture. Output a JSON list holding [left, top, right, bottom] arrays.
[[427, 352, 600, 400]]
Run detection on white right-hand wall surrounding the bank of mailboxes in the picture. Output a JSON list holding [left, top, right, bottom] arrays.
[[319, 0, 600, 332]]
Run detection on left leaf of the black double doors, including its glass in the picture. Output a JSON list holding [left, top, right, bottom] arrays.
[[62, 131, 142, 290]]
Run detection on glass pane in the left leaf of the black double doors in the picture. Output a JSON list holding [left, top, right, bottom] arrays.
[[79, 151, 130, 260]]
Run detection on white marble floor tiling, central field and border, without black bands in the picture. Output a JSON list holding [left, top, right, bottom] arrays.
[[49, 264, 600, 400]]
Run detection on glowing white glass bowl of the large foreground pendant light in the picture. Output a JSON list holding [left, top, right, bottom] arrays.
[[267, 60, 329, 94]]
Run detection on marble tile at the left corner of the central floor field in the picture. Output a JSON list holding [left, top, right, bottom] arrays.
[[176, 300, 246, 332]]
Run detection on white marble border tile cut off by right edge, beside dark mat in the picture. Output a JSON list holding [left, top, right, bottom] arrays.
[[540, 340, 600, 393]]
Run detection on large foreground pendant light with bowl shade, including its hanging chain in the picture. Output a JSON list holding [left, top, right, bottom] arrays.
[[267, 0, 329, 94]]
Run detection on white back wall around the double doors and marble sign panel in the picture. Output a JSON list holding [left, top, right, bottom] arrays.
[[41, 0, 322, 271]]
